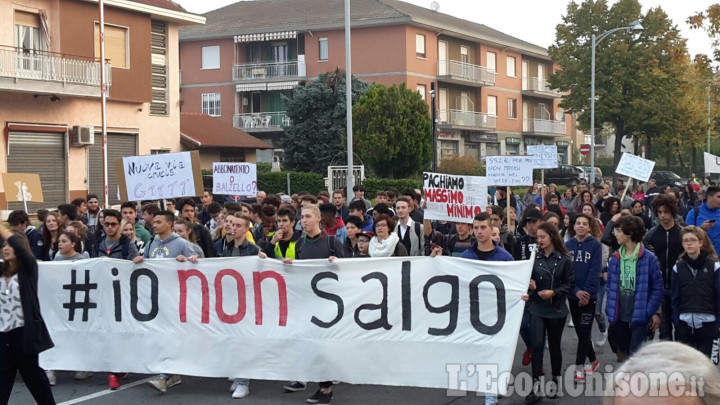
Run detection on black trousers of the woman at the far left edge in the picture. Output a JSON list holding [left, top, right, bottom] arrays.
[[0, 328, 55, 405]]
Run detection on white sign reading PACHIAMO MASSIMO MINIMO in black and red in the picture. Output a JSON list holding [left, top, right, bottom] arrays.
[[423, 172, 487, 224]]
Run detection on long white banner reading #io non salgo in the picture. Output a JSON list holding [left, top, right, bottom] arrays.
[[38, 256, 533, 394]]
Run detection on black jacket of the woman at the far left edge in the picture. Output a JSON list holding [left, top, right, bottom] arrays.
[[7, 236, 55, 355]]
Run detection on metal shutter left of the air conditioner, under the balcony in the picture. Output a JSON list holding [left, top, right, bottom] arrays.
[[5, 132, 68, 212]]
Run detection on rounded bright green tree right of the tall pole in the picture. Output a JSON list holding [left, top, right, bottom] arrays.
[[353, 83, 432, 178]]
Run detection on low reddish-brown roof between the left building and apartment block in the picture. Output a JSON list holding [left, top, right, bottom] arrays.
[[180, 113, 272, 149]]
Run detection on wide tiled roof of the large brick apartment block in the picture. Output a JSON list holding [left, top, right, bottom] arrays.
[[180, 0, 548, 59]]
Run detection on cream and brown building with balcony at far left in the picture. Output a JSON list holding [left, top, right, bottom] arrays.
[[0, 0, 205, 208]]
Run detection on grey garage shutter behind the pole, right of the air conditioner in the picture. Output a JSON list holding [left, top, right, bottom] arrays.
[[88, 133, 137, 205]]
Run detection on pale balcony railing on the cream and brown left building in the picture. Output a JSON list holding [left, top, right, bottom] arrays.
[[0, 47, 112, 87]]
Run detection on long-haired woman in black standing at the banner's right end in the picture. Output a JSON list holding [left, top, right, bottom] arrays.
[[525, 223, 575, 403]]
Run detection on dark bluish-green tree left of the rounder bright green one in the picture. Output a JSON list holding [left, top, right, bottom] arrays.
[[283, 69, 370, 173]]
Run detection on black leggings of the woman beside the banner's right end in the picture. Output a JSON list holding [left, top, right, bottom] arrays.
[[530, 315, 567, 379]]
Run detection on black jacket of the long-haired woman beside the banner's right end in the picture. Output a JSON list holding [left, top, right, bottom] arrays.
[[530, 250, 575, 318]]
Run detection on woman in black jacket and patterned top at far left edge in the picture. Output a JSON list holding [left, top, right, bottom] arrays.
[[0, 227, 55, 405]]
